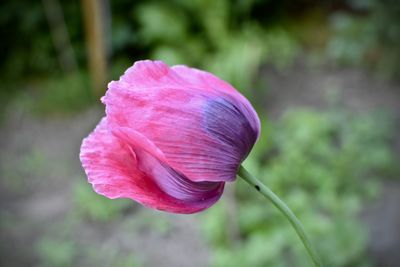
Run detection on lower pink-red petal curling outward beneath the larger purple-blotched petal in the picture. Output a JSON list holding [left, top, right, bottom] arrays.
[[80, 118, 224, 213]]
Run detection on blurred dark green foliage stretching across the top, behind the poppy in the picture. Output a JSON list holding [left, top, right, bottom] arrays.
[[0, 0, 400, 115]]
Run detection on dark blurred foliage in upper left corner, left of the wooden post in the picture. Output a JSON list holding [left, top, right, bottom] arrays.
[[0, 0, 84, 79]]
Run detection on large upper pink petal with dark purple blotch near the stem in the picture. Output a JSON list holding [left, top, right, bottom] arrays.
[[102, 61, 259, 182]]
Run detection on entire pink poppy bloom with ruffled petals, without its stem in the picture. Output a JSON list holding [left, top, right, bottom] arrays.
[[80, 60, 260, 213]]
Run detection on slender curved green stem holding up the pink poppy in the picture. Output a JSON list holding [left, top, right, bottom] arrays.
[[238, 166, 322, 267]]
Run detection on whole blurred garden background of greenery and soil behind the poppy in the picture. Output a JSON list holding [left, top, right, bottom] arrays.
[[0, 0, 400, 267]]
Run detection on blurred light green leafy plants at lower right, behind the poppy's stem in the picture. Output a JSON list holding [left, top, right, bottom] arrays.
[[204, 110, 395, 267]]
